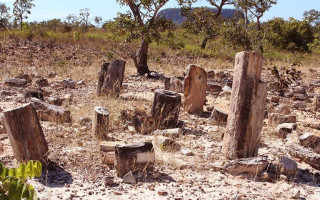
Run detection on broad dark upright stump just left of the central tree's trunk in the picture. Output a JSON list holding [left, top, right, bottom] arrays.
[[98, 60, 126, 96]]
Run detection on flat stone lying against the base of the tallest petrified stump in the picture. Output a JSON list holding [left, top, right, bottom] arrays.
[[223, 157, 269, 176]]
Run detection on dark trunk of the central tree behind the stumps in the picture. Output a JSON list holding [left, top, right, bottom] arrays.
[[135, 37, 150, 75]]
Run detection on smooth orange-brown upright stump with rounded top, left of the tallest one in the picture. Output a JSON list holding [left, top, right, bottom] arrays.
[[183, 65, 207, 114]]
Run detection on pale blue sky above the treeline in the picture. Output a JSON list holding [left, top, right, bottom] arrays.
[[0, 0, 320, 21]]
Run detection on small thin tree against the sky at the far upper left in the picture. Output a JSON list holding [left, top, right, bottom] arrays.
[[13, 0, 34, 30]]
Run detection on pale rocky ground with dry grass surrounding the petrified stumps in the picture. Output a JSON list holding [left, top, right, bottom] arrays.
[[0, 41, 320, 199]]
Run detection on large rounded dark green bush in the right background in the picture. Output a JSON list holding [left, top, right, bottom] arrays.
[[266, 18, 314, 51]]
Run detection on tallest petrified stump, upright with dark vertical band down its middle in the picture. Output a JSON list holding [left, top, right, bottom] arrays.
[[222, 52, 267, 159]]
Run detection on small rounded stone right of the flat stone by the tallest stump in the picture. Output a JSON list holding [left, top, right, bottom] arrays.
[[278, 156, 298, 177]]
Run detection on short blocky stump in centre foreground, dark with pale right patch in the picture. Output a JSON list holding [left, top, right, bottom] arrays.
[[115, 142, 155, 178]]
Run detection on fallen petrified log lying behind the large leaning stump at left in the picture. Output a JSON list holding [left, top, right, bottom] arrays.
[[30, 98, 72, 124]]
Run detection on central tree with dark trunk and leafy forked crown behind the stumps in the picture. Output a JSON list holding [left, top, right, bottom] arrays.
[[114, 0, 191, 75]]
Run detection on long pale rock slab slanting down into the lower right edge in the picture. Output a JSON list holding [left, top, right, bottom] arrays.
[[286, 144, 320, 170]]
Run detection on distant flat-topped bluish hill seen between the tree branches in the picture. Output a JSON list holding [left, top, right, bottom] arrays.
[[158, 8, 242, 25]]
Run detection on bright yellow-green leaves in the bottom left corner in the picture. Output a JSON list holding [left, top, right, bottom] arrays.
[[0, 161, 42, 200]]
